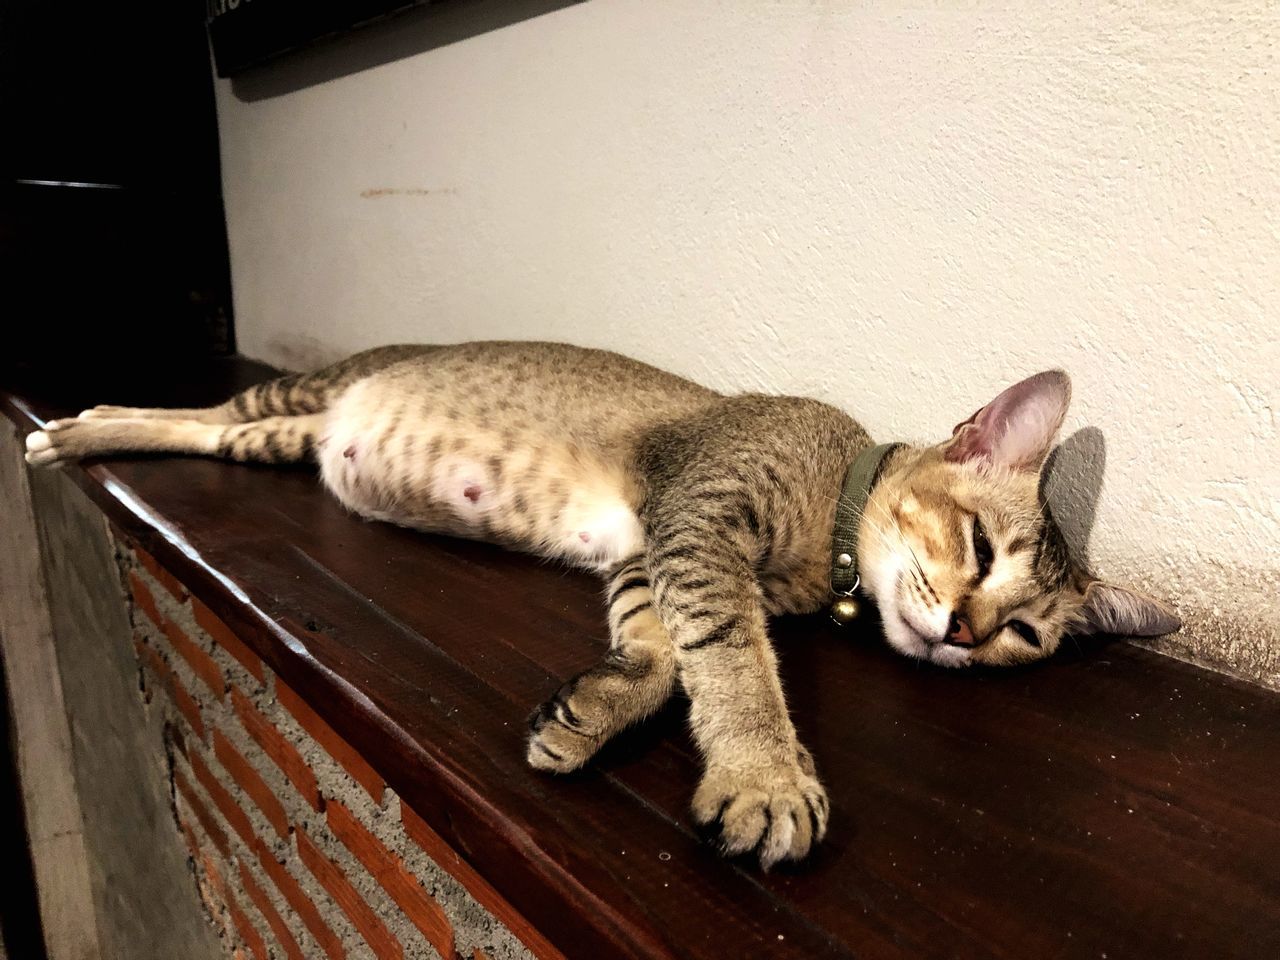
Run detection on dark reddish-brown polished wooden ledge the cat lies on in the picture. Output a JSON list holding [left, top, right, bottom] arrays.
[[0, 360, 1280, 959]]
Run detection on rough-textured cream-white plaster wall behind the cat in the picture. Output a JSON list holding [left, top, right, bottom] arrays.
[[219, 0, 1280, 685]]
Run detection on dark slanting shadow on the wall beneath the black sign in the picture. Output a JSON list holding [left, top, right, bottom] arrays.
[[232, 0, 582, 102]]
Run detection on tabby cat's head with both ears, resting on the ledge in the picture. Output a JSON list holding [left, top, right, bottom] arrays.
[[858, 370, 1181, 667]]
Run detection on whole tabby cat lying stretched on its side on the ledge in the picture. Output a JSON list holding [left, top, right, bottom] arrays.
[[27, 343, 1179, 868]]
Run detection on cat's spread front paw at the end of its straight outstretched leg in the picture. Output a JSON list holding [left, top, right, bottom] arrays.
[[694, 751, 831, 870]]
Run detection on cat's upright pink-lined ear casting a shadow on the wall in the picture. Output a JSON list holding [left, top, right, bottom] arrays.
[[943, 370, 1071, 470]]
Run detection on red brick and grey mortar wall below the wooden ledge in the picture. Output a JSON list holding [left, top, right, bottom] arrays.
[[116, 535, 559, 960]]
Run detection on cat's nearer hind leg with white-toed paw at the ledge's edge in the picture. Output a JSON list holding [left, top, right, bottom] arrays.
[[27, 415, 324, 466]]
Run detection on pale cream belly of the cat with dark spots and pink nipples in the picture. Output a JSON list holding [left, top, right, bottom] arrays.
[[319, 404, 644, 571]]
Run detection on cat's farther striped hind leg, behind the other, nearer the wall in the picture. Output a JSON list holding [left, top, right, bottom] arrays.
[[79, 346, 435, 424]]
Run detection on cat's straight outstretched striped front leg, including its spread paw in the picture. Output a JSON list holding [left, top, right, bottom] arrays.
[[645, 512, 828, 869]]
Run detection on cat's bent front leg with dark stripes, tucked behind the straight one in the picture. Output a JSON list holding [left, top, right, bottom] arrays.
[[527, 557, 676, 773]]
